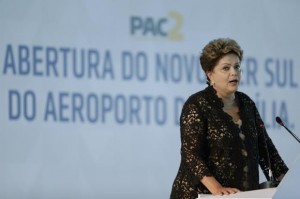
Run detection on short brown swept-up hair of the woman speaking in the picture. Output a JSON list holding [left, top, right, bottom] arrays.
[[200, 38, 243, 74]]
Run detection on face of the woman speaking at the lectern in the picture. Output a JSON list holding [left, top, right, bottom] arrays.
[[207, 53, 241, 97]]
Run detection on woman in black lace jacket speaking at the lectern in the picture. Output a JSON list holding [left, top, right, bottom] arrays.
[[170, 38, 288, 199]]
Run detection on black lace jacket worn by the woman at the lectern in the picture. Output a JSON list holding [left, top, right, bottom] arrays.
[[171, 86, 288, 199]]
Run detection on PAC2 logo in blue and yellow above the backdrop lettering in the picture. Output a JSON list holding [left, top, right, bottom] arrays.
[[130, 11, 183, 41]]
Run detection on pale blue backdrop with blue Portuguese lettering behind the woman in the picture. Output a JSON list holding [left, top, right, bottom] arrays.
[[0, 0, 300, 199]]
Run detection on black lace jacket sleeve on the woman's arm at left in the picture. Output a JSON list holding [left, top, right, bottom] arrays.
[[180, 104, 211, 180]]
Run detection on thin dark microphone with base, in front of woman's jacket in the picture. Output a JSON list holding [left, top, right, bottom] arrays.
[[259, 124, 279, 189]]
